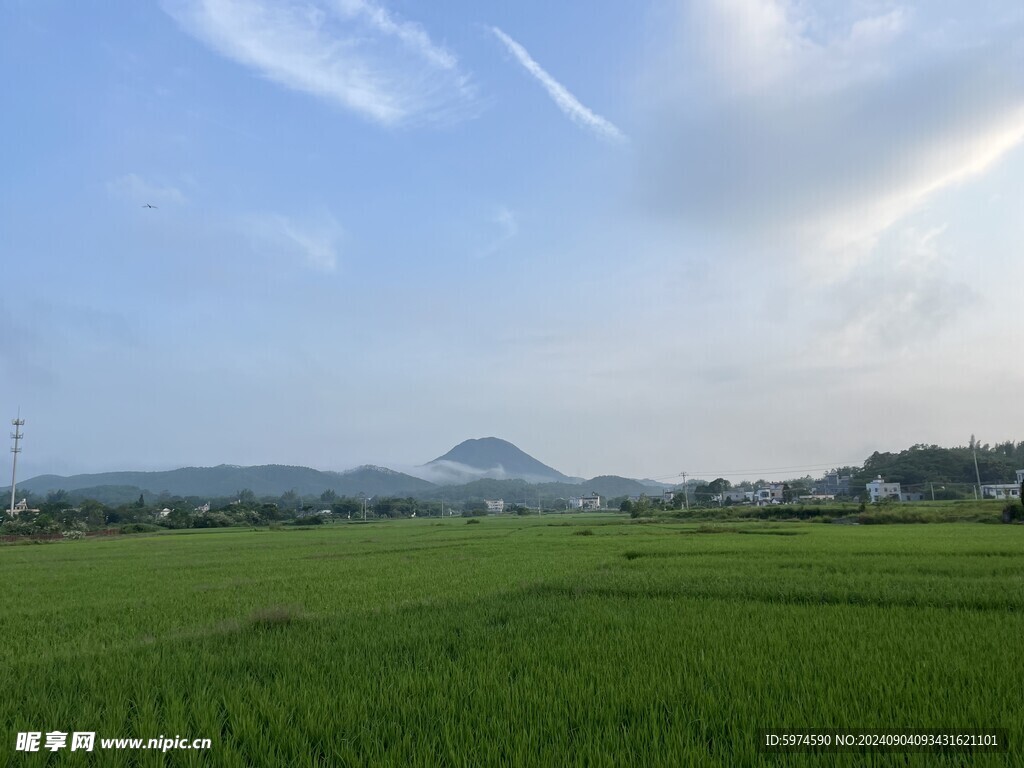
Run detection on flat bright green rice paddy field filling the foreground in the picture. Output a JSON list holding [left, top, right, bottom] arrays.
[[0, 515, 1024, 766]]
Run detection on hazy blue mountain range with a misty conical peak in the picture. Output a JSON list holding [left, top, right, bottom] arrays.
[[8, 437, 662, 504]]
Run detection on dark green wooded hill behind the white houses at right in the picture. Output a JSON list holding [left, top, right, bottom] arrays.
[[855, 440, 1024, 484]]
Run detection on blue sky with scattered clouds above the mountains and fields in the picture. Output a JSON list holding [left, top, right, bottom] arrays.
[[0, 0, 1024, 484]]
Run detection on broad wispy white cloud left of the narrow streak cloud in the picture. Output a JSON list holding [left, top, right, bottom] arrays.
[[165, 0, 474, 126]]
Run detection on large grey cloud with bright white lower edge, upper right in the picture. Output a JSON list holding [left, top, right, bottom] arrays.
[[640, 0, 1024, 270]]
